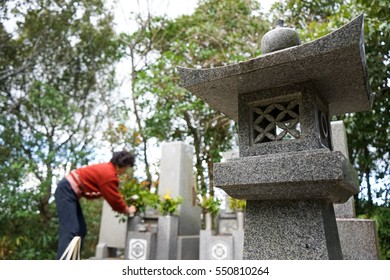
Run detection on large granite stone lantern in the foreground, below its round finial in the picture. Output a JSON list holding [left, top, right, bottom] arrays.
[[178, 16, 372, 259]]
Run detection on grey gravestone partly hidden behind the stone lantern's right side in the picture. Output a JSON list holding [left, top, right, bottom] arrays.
[[331, 121, 379, 260]]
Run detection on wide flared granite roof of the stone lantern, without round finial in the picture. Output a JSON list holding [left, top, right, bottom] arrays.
[[177, 15, 373, 121]]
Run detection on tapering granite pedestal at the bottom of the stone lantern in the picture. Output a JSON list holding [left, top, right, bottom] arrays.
[[244, 200, 342, 260]]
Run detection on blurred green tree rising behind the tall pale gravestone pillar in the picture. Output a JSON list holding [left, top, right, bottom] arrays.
[[123, 0, 267, 196]]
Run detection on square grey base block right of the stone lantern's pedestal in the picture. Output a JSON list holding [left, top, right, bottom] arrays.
[[336, 218, 379, 260]]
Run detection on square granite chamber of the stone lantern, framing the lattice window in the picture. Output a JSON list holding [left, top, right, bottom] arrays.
[[238, 82, 331, 157]]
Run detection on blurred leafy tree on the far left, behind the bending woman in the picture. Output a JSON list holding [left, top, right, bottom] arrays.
[[0, 0, 119, 259]]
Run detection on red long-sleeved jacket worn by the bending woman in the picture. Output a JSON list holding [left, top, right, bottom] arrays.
[[76, 162, 127, 213]]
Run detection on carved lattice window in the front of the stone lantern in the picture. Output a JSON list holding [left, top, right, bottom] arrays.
[[252, 99, 301, 144]]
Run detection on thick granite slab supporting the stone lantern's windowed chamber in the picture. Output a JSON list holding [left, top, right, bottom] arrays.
[[214, 149, 359, 203]]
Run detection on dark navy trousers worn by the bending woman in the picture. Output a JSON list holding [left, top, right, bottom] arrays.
[[54, 179, 87, 259]]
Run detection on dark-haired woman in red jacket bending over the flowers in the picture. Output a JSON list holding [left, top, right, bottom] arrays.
[[54, 151, 136, 259]]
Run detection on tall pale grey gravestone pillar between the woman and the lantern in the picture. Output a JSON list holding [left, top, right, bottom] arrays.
[[157, 142, 201, 260]]
